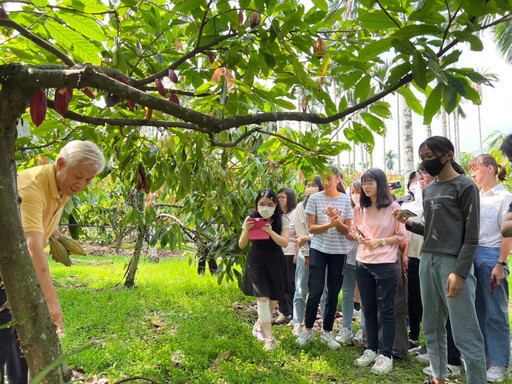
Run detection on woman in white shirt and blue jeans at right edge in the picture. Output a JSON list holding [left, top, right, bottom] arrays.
[[468, 154, 512, 382]]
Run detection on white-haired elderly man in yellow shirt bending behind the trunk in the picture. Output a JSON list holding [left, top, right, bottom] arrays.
[[0, 140, 105, 384]]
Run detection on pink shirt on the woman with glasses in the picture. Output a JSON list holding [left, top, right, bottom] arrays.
[[354, 201, 407, 264]]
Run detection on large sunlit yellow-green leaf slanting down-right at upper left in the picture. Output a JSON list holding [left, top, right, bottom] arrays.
[[45, 20, 101, 65]]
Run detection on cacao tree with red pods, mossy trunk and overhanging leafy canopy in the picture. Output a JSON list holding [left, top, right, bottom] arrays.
[[0, 0, 512, 384]]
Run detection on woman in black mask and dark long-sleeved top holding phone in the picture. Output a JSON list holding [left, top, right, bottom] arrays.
[[394, 136, 487, 384]]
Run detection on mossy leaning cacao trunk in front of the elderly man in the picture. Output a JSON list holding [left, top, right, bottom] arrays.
[[0, 79, 71, 384]]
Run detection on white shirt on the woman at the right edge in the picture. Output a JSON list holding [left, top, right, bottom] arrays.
[[478, 184, 512, 247]]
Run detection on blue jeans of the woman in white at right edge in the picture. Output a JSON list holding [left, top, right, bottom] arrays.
[[474, 247, 510, 367]]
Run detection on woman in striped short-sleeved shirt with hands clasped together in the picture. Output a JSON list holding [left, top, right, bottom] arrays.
[[297, 166, 353, 349]]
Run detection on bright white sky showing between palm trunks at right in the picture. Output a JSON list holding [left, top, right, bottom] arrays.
[[340, 33, 512, 170]]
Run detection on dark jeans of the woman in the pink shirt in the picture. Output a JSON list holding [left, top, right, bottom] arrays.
[[356, 262, 397, 357]]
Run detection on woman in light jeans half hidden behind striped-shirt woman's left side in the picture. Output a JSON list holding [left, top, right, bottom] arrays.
[[292, 176, 325, 336]]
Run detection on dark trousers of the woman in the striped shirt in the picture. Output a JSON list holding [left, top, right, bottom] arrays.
[[306, 248, 347, 332]]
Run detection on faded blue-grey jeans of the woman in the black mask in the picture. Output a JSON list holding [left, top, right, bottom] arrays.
[[420, 252, 487, 384]]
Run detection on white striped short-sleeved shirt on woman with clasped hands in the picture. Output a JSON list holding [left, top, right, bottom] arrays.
[[306, 192, 354, 255]]
